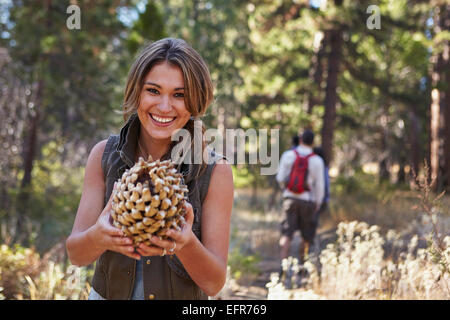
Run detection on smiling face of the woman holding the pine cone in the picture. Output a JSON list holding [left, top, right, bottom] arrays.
[[137, 62, 191, 141]]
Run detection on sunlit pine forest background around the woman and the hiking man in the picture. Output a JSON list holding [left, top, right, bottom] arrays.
[[0, 0, 450, 300]]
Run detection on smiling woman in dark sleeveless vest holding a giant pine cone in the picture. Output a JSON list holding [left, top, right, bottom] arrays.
[[66, 38, 233, 299]]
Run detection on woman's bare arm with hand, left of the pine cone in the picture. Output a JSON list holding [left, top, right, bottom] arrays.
[[66, 140, 139, 266]]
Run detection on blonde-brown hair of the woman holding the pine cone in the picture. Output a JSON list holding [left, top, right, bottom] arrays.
[[123, 38, 214, 169]]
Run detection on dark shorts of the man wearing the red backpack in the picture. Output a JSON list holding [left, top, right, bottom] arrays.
[[281, 198, 317, 242]]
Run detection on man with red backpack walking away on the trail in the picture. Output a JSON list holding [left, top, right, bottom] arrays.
[[276, 130, 325, 264]]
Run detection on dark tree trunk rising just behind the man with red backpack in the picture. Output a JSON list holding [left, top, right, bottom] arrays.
[[322, 26, 343, 166]]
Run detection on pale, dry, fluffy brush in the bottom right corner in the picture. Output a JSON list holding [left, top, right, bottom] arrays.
[[267, 221, 450, 300]]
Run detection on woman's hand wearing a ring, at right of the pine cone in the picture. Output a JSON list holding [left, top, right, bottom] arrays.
[[136, 202, 195, 256]]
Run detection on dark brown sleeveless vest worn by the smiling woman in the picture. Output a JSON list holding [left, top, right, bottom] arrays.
[[92, 114, 223, 300]]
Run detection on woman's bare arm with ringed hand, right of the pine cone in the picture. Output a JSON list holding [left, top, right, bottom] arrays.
[[138, 160, 233, 296]]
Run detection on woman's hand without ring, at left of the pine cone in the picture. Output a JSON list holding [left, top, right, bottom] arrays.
[[92, 184, 140, 260]]
